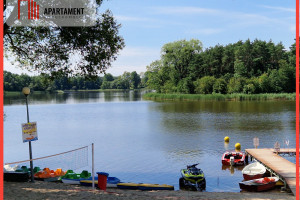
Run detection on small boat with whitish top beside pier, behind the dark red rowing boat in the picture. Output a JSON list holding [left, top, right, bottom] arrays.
[[242, 162, 266, 181]]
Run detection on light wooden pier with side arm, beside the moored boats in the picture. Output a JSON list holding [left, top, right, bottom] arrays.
[[245, 149, 296, 195]]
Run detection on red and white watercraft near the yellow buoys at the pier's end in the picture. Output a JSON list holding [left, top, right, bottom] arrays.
[[222, 151, 245, 166]]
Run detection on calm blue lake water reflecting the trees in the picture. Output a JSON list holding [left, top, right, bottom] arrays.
[[4, 91, 296, 192]]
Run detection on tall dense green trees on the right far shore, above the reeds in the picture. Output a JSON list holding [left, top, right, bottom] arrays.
[[145, 39, 296, 94]]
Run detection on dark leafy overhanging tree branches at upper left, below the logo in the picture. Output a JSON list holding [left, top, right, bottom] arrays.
[[4, 0, 125, 78]]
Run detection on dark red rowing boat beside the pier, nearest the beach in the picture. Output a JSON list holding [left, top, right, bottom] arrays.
[[239, 177, 279, 192]]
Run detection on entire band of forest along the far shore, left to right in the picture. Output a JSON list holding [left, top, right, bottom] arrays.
[[4, 39, 296, 94]]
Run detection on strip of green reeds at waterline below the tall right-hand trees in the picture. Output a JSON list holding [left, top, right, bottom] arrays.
[[143, 93, 296, 101]]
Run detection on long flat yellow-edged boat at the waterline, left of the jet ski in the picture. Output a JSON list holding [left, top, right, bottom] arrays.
[[117, 183, 174, 190]]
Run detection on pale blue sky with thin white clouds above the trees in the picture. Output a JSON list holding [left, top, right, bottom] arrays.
[[4, 0, 296, 76]]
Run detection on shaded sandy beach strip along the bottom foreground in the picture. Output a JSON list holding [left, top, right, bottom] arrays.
[[4, 181, 295, 200]]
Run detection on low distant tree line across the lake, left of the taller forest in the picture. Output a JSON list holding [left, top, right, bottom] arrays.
[[3, 71, 141, 92]]
